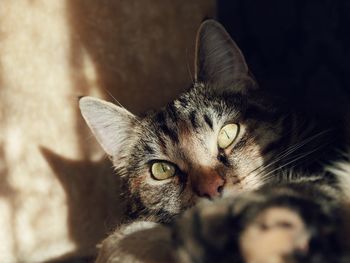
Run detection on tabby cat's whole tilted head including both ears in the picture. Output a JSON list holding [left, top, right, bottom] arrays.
[[80, 20, 283, 223]]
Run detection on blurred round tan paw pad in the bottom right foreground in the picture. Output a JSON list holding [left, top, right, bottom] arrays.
[[239, 207, 310, 263]]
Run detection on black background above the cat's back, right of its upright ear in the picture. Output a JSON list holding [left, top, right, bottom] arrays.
[[217, 0, 350, 112]]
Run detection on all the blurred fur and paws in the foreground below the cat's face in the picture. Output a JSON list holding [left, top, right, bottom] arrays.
[[97, 157, 350, 263]]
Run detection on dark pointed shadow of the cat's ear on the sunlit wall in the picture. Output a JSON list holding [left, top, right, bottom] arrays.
[[40, 147, 124, 261]]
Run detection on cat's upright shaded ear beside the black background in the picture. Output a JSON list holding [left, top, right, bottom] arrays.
[[195, 20, 255, 89]]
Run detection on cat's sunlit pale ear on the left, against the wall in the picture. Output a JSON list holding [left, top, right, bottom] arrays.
[[79, 97, 136, 158]]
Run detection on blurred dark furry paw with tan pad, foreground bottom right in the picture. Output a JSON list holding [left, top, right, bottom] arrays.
[[174, 185, 342, 263]]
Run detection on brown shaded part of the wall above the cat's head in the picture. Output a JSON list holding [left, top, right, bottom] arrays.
[[67, 0, 213, 113]]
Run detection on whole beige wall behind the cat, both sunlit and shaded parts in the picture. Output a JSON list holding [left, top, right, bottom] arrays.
[[0, 0, 215, 262]]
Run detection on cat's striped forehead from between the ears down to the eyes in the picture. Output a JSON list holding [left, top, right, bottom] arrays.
[[139, 88, 241, 165]]
